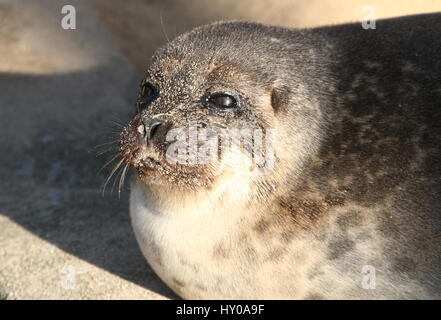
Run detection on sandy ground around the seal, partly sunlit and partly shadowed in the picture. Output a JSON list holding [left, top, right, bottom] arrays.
[[0, 0, 441, 299]]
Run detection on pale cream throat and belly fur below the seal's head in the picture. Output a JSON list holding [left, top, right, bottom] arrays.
[[130, 181, 425, 299]]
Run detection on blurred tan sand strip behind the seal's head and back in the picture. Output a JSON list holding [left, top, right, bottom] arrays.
[[92, 0, 441, 70]]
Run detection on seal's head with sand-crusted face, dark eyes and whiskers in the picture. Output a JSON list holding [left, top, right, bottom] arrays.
[[120, 23, 332, 195]]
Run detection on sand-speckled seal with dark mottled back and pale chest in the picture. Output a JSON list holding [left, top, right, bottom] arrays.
[[119, 14, 441, 299]]
